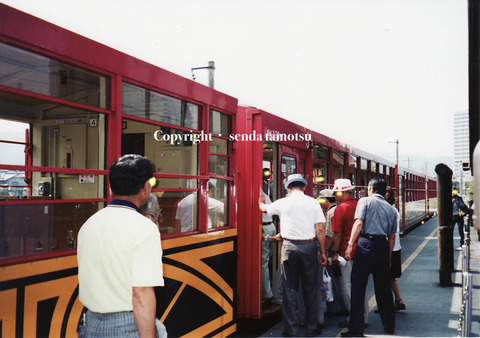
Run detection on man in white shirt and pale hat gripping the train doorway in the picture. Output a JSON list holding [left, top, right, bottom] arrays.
[[259, 174, 327, 336]]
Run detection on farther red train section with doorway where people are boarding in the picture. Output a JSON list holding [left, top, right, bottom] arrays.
[[235, 107, 436, 318]]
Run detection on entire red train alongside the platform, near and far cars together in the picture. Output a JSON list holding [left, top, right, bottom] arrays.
[[0, 4, 436, 337]]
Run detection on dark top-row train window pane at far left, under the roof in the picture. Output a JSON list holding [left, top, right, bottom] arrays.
[[0, 43, 108, 108]]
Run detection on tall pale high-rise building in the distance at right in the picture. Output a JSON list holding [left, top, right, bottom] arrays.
[[453, 112, 472, 192]]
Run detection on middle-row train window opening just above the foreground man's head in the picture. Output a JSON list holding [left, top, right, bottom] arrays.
[[122, 120, 199, 174]]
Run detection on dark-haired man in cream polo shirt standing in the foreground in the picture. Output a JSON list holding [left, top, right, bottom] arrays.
[[77, 155, 166, 337]]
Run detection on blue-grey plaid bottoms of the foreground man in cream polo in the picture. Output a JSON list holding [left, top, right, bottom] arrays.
[[78, 310, 167, 338]]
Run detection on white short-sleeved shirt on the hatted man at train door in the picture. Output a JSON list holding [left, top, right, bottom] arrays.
[[265, 190, 325, 239]]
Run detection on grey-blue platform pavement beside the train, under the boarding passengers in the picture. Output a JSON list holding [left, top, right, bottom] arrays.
[[253, 218, 480, 337]]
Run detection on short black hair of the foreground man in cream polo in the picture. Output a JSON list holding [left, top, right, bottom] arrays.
[[109, 154, 153, 196]]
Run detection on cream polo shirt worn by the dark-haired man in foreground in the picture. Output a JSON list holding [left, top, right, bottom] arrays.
[[77, 201, 164, 313]]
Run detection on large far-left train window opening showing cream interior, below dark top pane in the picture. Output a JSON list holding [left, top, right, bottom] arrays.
[[0, 103, 105, 199]]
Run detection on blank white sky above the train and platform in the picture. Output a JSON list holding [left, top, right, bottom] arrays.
[[2, 0, 468, 174]]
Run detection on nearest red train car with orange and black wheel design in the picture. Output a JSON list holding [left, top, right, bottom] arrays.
[[0, 4, 237, 337]]
